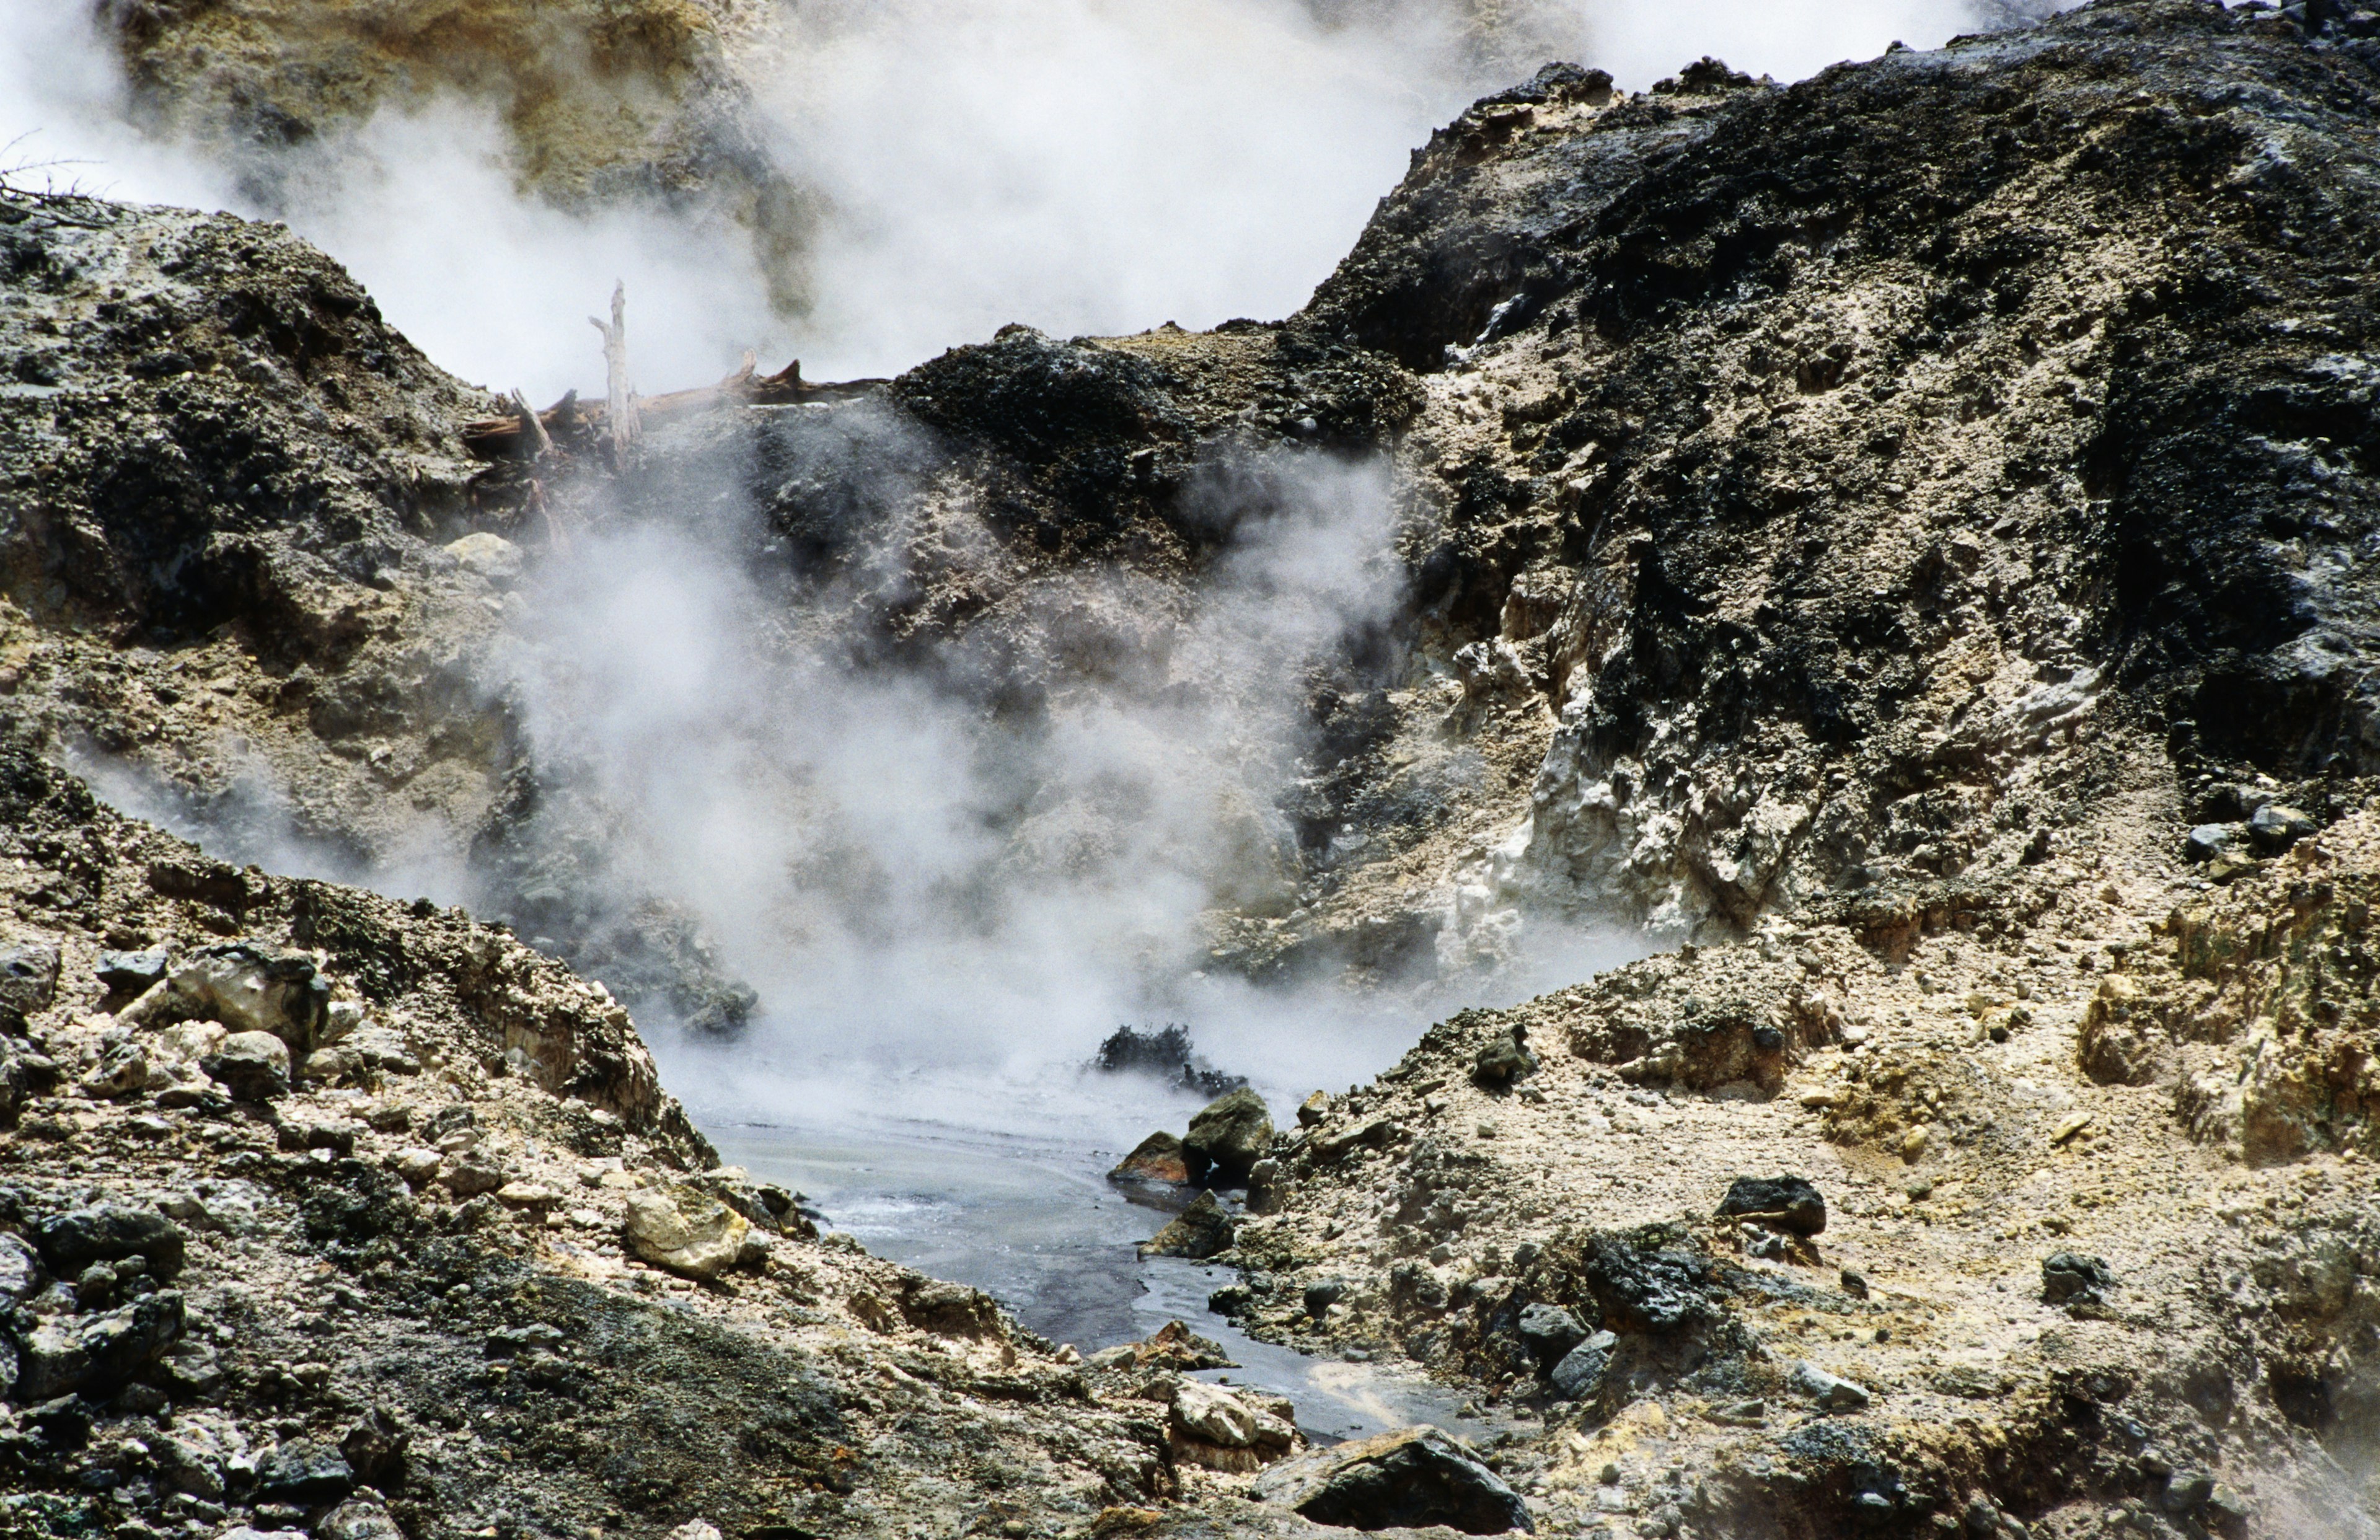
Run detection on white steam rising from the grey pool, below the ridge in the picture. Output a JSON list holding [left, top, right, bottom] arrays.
[[507, 440, 1402, 1090]]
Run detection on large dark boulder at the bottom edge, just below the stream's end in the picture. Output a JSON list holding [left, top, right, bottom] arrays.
[[1254, 1428, 1535, 1535]]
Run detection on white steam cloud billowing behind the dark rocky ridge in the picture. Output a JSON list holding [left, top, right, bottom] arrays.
[[0, 0, 2037, 400]]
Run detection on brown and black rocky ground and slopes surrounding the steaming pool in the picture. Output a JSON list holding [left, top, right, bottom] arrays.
[[0, 0, 2380, 1540]]
